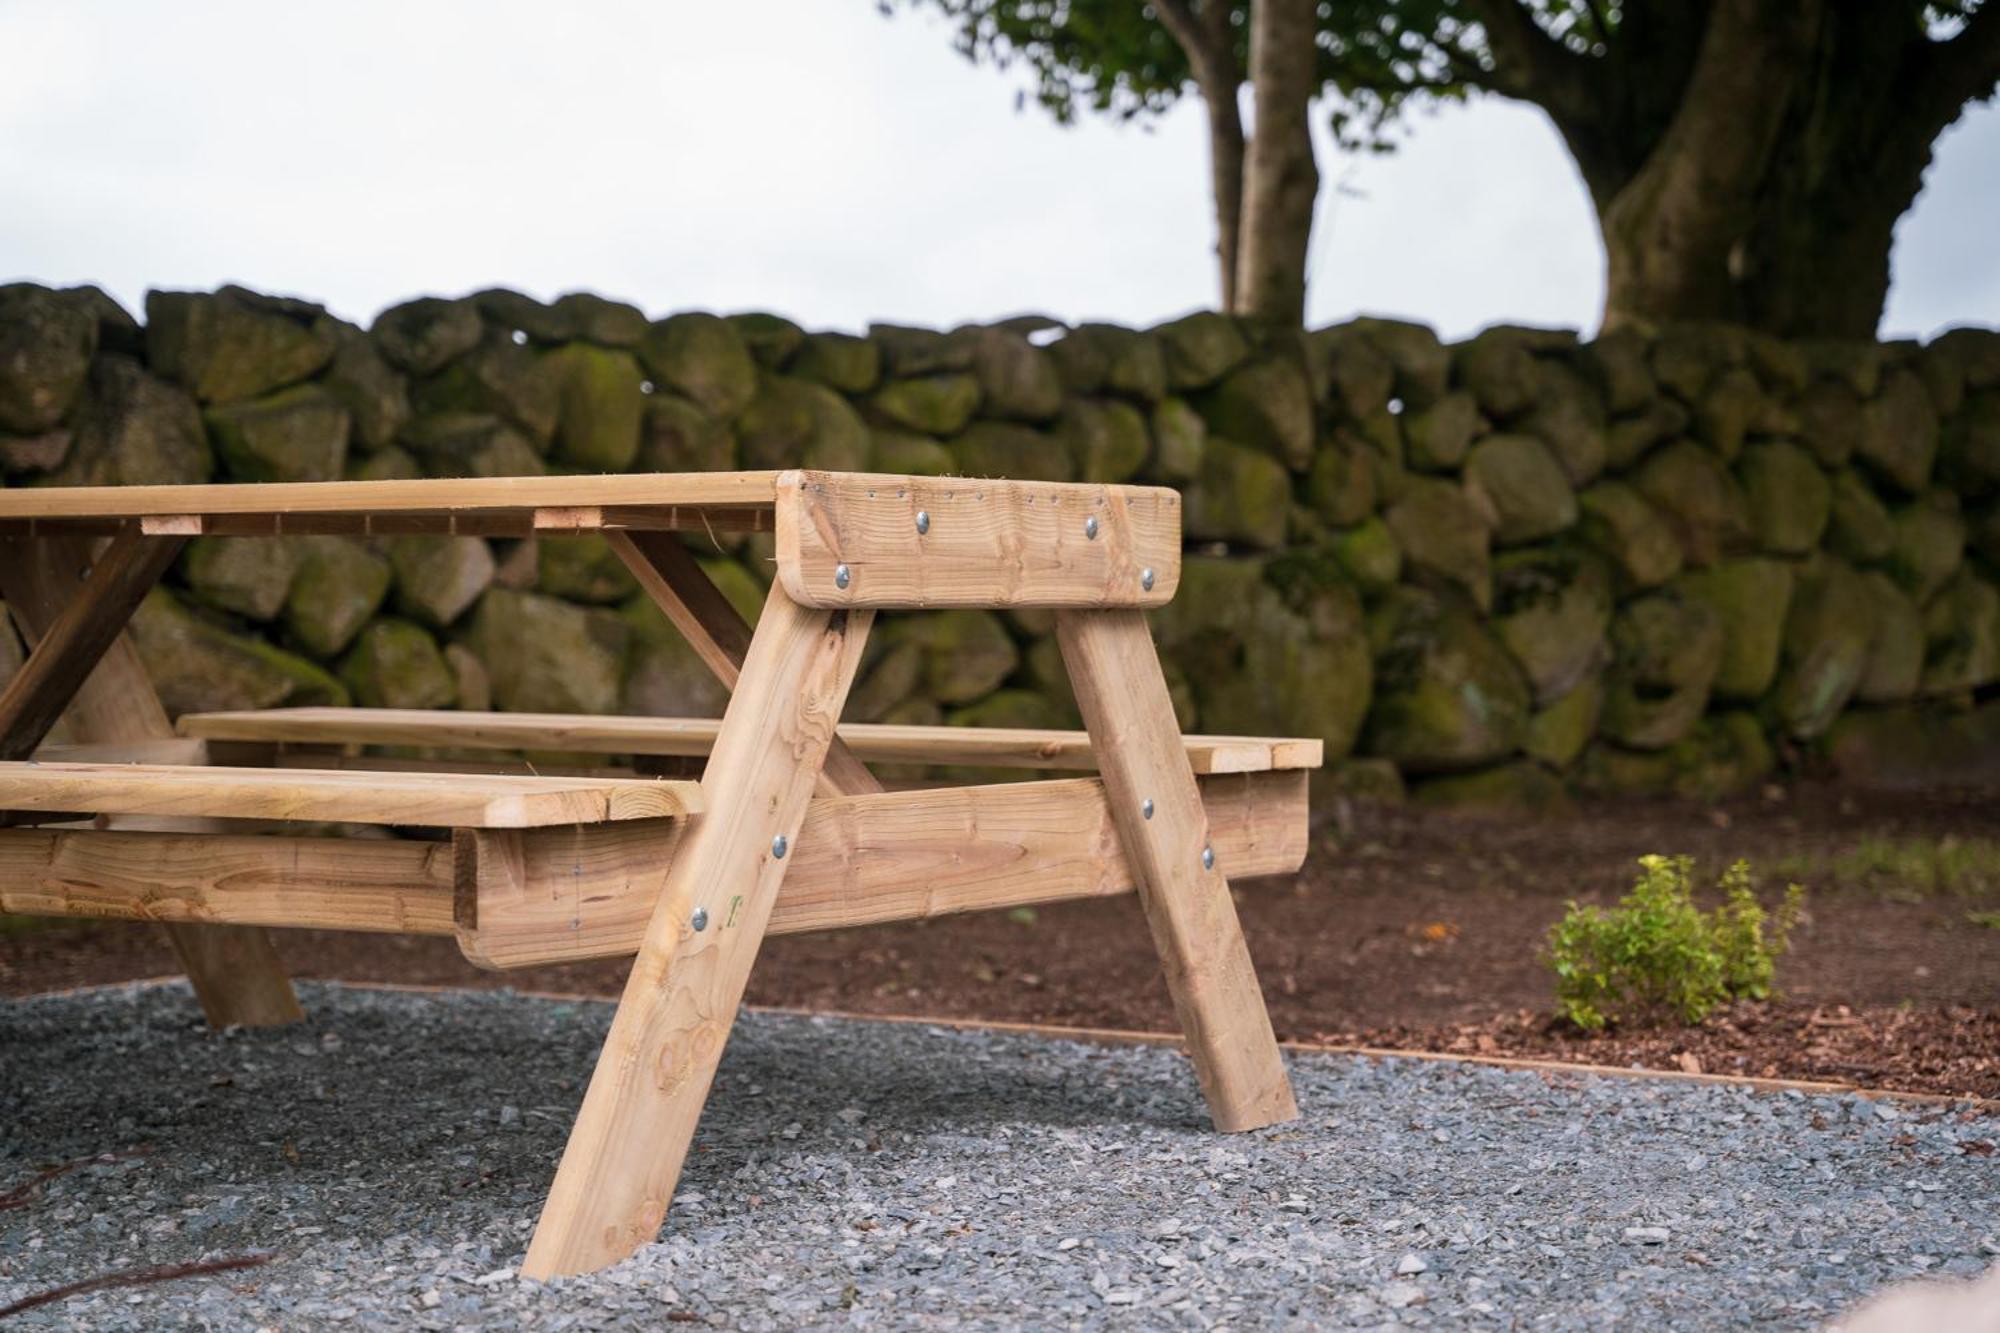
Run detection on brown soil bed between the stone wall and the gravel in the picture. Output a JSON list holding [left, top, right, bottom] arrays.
[[0, 787, 2000, 1097]]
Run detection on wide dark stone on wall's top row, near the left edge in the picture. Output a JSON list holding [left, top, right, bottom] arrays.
[[146, 286, 334, 402]]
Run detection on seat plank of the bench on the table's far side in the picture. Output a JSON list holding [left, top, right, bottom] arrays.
[[180, 709, 1322, 773]]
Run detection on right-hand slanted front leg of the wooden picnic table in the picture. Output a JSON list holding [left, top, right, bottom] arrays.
[[1056, 610, 1298, 1131]]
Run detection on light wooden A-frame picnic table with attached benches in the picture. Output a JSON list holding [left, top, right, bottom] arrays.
[[0, 470, 1320, 1277]]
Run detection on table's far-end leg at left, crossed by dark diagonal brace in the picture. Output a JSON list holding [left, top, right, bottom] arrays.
[[0, 536, 306, 1027]]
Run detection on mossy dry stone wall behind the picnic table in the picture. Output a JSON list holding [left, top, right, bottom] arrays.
[[0, 286, 2000, 809]]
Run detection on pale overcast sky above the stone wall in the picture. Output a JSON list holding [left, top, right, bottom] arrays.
[[0, 0, 2000, 336]]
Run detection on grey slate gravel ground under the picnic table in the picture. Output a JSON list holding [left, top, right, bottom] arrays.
[[0, 985, 2000, 1329]]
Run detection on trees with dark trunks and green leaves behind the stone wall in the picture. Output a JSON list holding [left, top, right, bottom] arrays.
[[902, 0, 2000, 338]]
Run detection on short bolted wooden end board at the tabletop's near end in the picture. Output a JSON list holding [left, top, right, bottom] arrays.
[[776, 472, 1180, 608]]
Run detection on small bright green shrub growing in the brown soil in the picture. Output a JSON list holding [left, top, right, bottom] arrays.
[[1548, 857, 1806, 1031]]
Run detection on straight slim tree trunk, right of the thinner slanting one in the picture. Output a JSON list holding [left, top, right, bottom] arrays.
[[1232, 0, 1320, 328]]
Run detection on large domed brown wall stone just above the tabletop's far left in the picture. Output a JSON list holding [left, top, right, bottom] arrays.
[[48, 356, 214, 486]]
